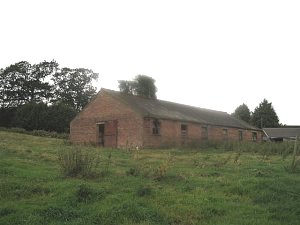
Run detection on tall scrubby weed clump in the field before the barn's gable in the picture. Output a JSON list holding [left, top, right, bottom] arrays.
[[58, 147, 100, 177]]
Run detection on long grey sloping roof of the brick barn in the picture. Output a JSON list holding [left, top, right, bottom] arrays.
[[100, 89, 259, 130]]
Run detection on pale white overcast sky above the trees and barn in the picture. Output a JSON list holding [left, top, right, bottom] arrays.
[[0, 0, 300, 125]]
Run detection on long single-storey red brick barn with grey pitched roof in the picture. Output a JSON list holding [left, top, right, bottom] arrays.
[[70, 88, 262, 148]]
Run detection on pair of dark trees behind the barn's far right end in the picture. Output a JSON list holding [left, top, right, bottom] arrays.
[[233, 99, 281, 128]]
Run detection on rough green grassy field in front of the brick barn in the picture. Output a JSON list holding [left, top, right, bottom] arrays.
[[0, 131, 300, 225]]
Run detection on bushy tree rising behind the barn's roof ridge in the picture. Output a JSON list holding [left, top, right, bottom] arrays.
[[118, 75, 157, 99]]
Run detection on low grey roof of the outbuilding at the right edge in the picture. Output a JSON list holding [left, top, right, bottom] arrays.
[[263, 127, 300, 138]]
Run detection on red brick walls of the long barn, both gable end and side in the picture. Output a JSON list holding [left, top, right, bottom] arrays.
[[70, 91, 261, 148]]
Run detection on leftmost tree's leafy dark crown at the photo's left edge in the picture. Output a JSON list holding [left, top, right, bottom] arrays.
[[0, 61, 58, 108]]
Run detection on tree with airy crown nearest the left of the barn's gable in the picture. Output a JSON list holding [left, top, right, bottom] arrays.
[[52, 68, 99, 110]]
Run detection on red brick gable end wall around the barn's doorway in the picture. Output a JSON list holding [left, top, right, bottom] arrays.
[[70, 91, 143, 147]]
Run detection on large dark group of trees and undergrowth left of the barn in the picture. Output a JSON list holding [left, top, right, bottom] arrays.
[[0, 60, 99, 132]]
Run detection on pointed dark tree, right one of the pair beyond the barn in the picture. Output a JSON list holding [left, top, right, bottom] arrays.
[[251, 99, 280, 128]]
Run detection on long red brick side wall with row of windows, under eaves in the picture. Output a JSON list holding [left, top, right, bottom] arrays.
[[143, 118, 262, 147]]
